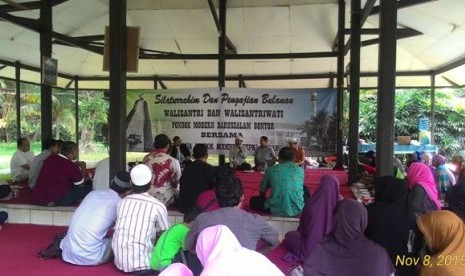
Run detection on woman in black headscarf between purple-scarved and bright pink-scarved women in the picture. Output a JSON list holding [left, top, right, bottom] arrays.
[[365, 176, 418, 276]]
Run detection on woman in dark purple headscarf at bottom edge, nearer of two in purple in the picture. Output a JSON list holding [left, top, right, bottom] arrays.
[[304, 199, 394, 276]]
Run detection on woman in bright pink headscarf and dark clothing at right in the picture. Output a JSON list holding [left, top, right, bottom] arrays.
[[407, 162, 441, 221]]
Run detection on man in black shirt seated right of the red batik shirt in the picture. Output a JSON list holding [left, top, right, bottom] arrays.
[[178, 144, 215, 213]]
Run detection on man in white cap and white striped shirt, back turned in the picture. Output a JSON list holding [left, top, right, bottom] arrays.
[[112, 164, 170, 274]]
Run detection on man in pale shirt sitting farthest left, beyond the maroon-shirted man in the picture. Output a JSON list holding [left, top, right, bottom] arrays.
[[10, 138, 35, 182]]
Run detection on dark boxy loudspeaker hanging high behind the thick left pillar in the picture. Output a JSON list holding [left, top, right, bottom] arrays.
[[103, 26, 140, 73]]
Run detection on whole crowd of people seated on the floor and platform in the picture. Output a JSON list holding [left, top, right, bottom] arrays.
[[0, 134, 465, 276]]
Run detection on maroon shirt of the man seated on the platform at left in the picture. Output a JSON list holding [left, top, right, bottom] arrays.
[[32, 154, 84, 205]]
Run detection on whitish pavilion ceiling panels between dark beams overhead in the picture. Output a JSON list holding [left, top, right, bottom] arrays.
[[0, 0, 465, 89]]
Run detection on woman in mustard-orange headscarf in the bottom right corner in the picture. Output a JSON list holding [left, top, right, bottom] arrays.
[[417, 210, 465, 276]]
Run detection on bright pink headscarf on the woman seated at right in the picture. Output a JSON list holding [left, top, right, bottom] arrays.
[[407, 162, 441, 209]]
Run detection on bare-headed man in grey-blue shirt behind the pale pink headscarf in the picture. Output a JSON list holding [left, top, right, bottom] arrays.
[[186, 176, 279, 252]]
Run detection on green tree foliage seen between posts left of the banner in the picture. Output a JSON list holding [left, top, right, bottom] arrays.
[[0, 79, 108, 151]]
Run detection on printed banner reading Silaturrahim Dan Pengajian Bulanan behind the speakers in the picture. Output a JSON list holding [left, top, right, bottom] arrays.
[[126, 88, 336, 156]]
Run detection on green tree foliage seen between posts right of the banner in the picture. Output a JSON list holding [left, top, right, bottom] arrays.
[[359, 89, 465, 154]]
